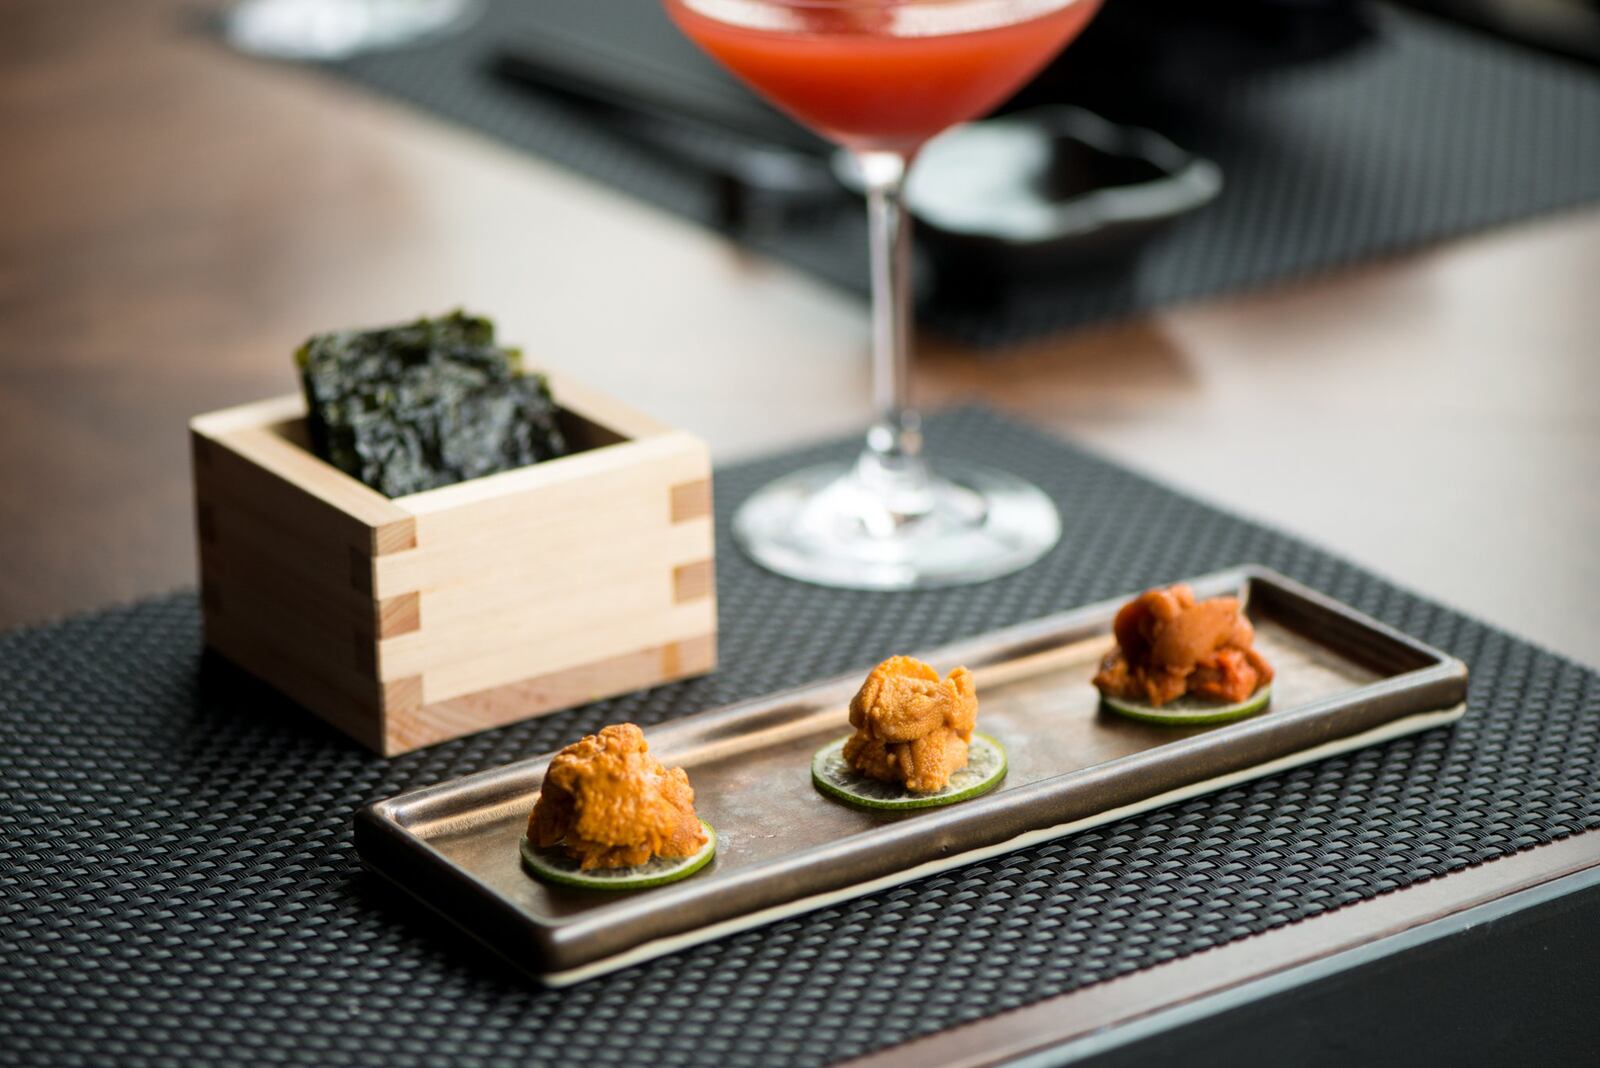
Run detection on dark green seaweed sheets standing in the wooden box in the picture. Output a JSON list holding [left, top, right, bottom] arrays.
[[294, 312, 566, 497]]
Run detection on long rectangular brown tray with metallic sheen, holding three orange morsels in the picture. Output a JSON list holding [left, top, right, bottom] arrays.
[[355, 568, 1467, 985]]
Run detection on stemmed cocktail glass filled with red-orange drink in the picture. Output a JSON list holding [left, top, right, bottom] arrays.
[[664, 0, 1099, 590]]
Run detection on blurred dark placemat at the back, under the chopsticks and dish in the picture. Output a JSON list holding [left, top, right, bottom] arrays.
[[308, 0, 1600, 345]]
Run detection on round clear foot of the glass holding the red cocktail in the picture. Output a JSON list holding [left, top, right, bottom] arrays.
[[733, 457, 1061, 590]]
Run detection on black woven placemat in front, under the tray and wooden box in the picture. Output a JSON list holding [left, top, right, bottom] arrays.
[[0, 409, 1600, 1068]]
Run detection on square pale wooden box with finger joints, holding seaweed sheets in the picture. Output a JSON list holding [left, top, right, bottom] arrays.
[[189, 376, 717, 756]]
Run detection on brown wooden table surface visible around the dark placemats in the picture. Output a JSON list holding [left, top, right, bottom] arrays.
[[0, 0, 1600, 1063]]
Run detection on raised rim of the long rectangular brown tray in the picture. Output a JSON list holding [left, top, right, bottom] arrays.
[[355, 564, 1467, 986]]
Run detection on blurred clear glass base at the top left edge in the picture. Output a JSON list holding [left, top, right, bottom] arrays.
[[224, 0, 483, 59]]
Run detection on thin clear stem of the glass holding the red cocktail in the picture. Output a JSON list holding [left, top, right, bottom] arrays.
[[856, 152, 933, 537]]
